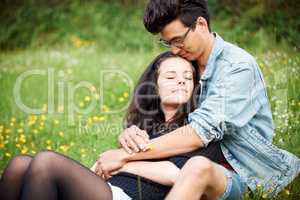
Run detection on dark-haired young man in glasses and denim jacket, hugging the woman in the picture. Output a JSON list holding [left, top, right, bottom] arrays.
[[119, 0, 300, 200]]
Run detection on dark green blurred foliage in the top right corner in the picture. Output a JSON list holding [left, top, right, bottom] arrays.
[[209, 0, 300, 45]]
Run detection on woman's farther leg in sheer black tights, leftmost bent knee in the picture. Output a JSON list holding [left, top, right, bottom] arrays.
[[0, 155, 32, 200]]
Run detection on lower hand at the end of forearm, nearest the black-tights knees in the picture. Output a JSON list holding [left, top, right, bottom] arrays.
[[95, 149, 128, 179]]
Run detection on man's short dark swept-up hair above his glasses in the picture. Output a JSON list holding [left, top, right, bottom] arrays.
[[144, 0, 210, 34]]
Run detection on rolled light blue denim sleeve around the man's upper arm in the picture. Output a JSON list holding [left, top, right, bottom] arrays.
[[189, 62, 264, 146]]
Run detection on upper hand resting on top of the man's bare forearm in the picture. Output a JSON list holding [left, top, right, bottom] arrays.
[[118, 125, 150, 154]]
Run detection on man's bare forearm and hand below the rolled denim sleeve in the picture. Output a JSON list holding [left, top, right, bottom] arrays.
[[91, 125, 204, 177]]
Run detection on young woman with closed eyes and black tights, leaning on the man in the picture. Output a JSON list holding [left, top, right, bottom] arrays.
[[0, 52, 230, 200]]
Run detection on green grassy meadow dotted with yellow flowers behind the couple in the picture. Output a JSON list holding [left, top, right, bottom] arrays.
[[0, 3, 300, 200]]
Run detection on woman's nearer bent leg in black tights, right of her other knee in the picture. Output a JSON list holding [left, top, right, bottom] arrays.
[[21, 151, 112, 200]]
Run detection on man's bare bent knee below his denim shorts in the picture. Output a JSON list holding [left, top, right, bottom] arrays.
[[166, 156, 227, 200]]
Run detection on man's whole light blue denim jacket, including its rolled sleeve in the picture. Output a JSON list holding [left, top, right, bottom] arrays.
[[188, 33, 300, 197]]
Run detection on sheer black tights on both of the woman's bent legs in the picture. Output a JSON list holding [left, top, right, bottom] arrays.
[[0, 151, 112, 200]]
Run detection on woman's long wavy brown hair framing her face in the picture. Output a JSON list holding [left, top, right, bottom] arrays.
[[124, 51, 200, 134]]
